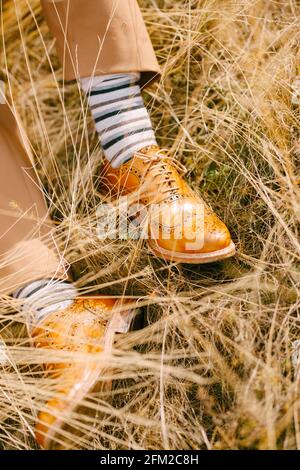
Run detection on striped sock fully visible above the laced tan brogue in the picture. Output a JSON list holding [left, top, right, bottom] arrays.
[[81, 73, 157, 168]]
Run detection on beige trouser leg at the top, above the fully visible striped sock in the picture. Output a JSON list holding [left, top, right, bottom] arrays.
[[41, 0, 160, 86]]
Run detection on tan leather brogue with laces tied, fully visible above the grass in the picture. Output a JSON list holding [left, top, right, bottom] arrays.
[[102, 146, 235, 263]]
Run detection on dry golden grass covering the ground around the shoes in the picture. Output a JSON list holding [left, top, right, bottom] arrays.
[[0, 0, 300, 449]]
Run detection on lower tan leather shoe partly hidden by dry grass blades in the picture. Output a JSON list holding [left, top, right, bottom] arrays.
[[32, 297, 135, 450]]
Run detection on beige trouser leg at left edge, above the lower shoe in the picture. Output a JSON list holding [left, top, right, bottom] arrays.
[[0, 104, 66, 295]]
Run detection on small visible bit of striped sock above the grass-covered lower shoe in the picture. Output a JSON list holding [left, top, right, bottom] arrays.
[[12, 279, 77, 326]]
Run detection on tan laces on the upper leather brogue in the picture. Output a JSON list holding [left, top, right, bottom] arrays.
[[135, 149, 187, 193]]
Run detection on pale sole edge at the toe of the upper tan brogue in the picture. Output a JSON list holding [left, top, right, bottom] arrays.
[[148, 241, 236, 264]]
